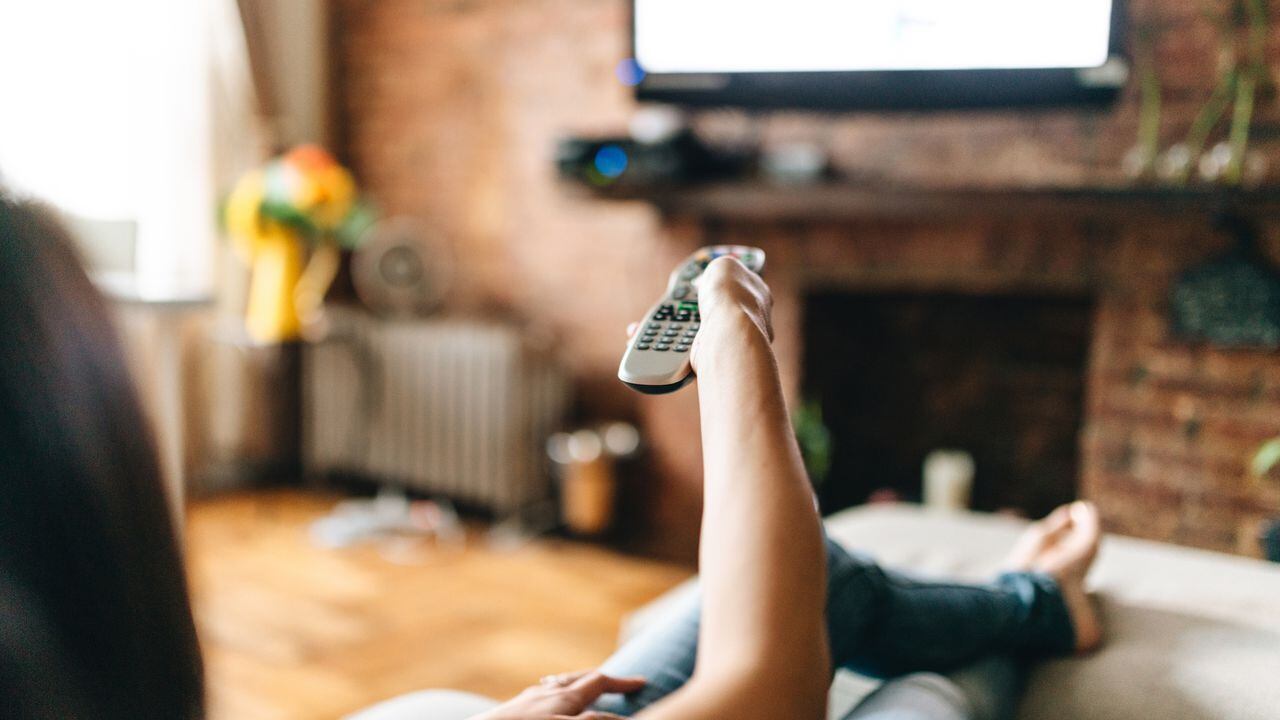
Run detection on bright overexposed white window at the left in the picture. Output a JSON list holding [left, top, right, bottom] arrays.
[[0, 0, 227, 301]]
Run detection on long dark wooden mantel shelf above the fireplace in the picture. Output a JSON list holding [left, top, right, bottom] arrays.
[[579, 182, 1280, 220]]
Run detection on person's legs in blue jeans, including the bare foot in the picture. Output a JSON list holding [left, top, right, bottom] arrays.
[[596, 502, 1098, 717]]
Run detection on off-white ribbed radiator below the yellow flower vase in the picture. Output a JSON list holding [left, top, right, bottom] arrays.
[[302, 309, 568, 514]]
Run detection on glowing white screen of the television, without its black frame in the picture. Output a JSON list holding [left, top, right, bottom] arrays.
[[635, 0, 1112, 73]]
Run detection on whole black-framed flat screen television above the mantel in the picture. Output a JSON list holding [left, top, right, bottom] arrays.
[[625, 0, 1129, 110]]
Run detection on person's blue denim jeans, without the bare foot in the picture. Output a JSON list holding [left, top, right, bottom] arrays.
[[595, 541, 1054, 716]]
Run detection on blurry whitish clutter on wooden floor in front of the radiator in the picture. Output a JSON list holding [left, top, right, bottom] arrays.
[[311, 489, 466, 562]]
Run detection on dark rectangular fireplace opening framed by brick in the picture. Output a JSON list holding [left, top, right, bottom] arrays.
[[803, 292, 1093, 516]]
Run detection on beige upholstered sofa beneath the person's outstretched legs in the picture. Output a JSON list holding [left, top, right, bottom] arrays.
[[352, 505, 1280, 720]]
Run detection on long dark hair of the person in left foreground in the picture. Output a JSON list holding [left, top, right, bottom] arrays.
[[0, 192, 204, 720]]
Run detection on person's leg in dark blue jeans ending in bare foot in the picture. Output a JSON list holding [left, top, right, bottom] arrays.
[[827, 502, 1102, 678]]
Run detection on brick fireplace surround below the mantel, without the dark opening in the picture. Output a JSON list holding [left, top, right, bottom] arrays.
[[714, 218, 1280, 555]]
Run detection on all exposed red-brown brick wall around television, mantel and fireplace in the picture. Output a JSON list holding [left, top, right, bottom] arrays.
[[333, 0, 1280, 552]]
